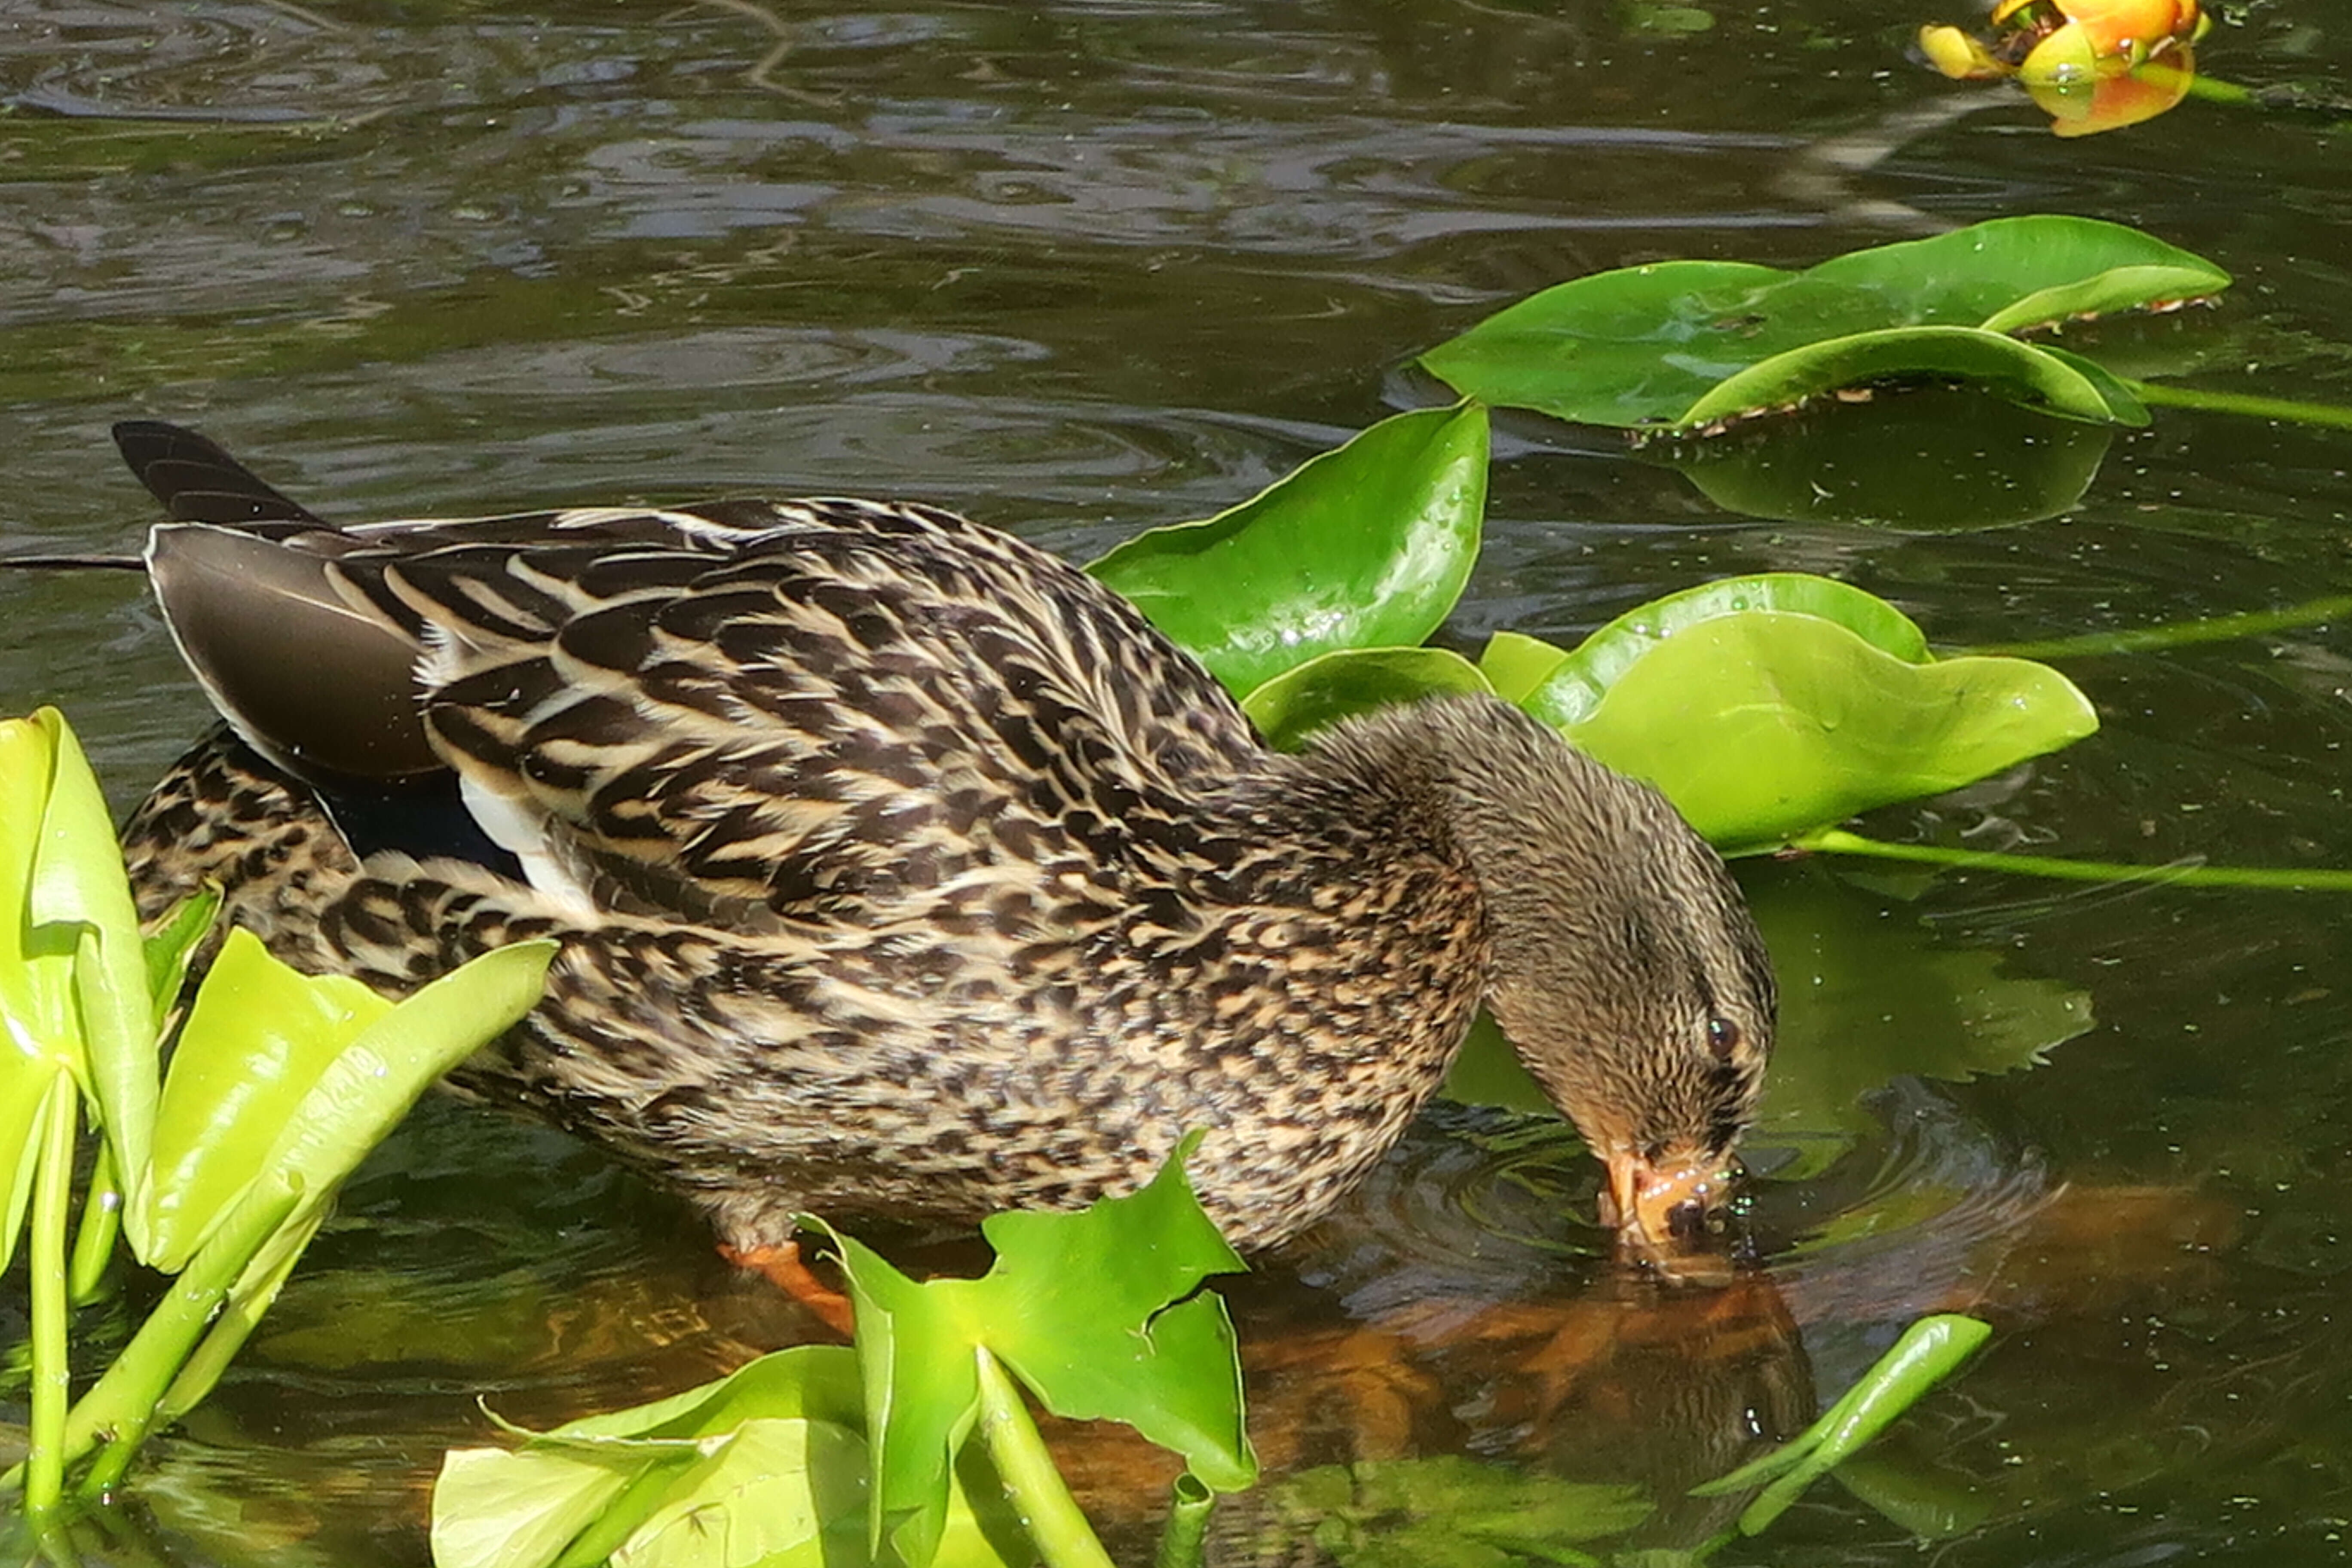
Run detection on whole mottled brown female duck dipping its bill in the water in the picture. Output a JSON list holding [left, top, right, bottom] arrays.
[[115, 423, 1773, 1256]]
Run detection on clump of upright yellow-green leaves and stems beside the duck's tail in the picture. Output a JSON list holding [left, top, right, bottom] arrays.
[[0, 707, 553, 1537]]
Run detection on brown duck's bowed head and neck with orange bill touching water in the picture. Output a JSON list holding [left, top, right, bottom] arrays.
[[1354, 698, 1776, 1267]]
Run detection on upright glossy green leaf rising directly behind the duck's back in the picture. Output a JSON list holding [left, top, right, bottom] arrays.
[[1087, 404, 1486, 696]]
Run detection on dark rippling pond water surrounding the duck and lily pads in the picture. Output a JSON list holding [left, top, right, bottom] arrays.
[[0, 0, 2352, 1568]]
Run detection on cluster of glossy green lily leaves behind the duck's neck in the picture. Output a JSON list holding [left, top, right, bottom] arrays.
[[1091, 404, 2098, 853]]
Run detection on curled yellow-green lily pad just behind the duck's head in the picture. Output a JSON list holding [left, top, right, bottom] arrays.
[[1489, 574, 2098, 853]]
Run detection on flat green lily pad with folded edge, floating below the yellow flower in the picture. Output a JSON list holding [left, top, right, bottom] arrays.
[[1421, 216, 2230, 430]]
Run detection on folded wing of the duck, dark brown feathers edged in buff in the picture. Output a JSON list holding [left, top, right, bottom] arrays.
[[124, 420, 1261, 928]]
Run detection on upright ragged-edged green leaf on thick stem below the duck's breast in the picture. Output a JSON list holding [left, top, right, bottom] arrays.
[[833, 1140, 1259, 1568]]
